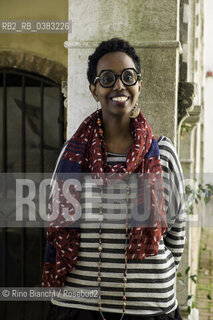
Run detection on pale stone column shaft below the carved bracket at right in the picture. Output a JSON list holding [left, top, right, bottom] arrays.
[[177, 106, 203, 319]]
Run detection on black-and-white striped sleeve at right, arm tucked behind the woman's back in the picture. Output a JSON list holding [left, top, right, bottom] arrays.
[[159, 137, 186, 268]]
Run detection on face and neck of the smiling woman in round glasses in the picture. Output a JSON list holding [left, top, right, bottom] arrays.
[[88, 51, 142, 153]]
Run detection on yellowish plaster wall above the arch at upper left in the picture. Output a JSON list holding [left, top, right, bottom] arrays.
[[0, 0, 68, 69]]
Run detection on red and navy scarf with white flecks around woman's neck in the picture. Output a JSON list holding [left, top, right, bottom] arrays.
[[42, 110, 167, 287]]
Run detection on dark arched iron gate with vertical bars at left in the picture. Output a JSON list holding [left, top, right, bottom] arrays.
[[0, 69, 64, 320]]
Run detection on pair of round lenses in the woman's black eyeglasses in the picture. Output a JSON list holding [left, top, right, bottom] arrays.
[[99, 69, 137, 87]]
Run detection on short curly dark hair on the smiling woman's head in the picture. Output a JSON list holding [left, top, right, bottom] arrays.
[[87, 38, 141, 84]]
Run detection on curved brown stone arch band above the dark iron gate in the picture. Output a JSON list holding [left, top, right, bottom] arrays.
[[0, 50, 67, 84]]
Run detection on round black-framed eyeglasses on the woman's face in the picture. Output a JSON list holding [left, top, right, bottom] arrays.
[[94, 68, 141, 88]]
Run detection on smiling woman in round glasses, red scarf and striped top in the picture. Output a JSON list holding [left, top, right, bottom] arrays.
[[43, 38, 185, 320]]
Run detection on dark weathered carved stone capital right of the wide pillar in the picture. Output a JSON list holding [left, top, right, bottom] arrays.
[[178, 82, 195, 124]]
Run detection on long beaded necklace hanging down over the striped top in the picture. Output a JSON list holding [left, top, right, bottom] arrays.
[[97, 114, 130, 320]]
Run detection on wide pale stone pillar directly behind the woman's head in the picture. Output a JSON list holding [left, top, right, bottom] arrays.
[[65, 0, 180, 142]]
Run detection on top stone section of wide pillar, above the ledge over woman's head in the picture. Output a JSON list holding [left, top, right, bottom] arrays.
[[69, 0, 179, 43]]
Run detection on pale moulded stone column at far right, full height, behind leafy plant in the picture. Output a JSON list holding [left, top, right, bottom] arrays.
[[177, 0, 204, 318]]
